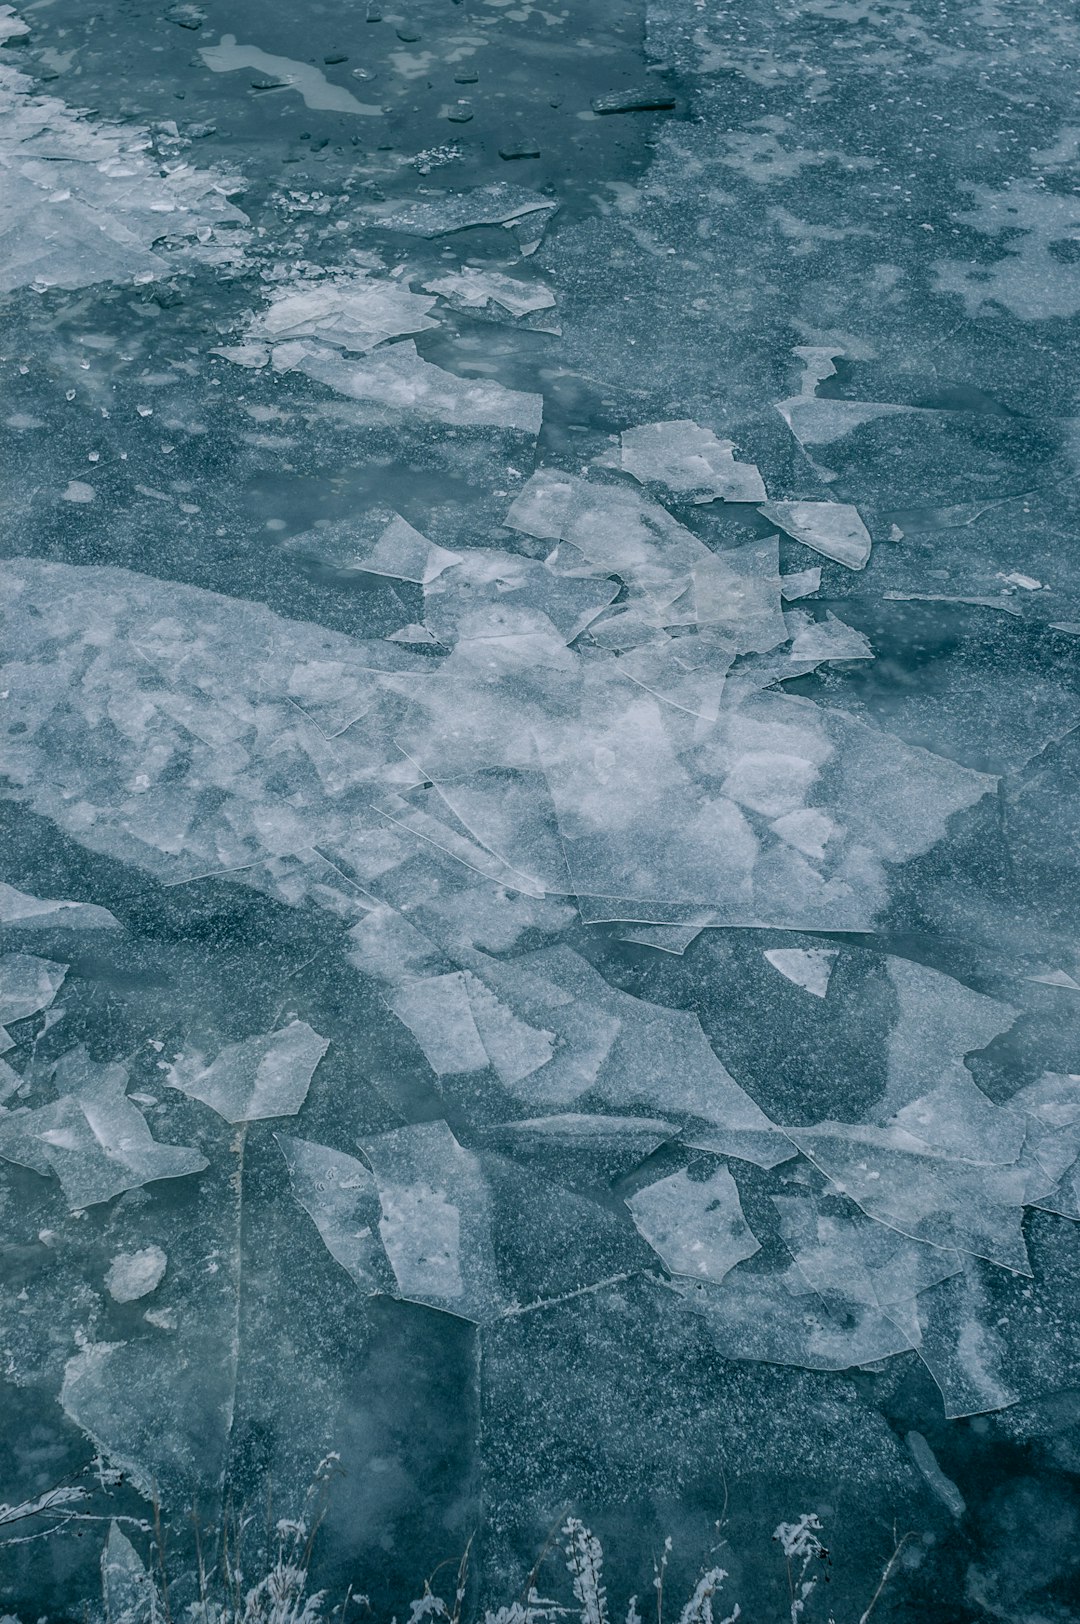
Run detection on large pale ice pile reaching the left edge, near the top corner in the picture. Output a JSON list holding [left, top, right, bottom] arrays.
[[0, 52, 248, 292]]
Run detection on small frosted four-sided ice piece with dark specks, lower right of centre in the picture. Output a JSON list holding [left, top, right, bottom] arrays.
[[627, 1168, 762, 1281]]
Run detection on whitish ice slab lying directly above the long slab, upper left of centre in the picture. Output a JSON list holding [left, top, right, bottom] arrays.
[[245, 274, 438, 359]]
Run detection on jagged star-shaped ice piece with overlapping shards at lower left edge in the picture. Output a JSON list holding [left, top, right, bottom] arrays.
[[0, 1046, 208, 1210]]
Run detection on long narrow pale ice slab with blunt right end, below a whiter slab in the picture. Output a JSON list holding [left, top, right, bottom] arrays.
[[273, 338, 544, 434]]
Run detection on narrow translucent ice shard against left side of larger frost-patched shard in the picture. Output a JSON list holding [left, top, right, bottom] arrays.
[[276, 1134, 393, 1294]]
